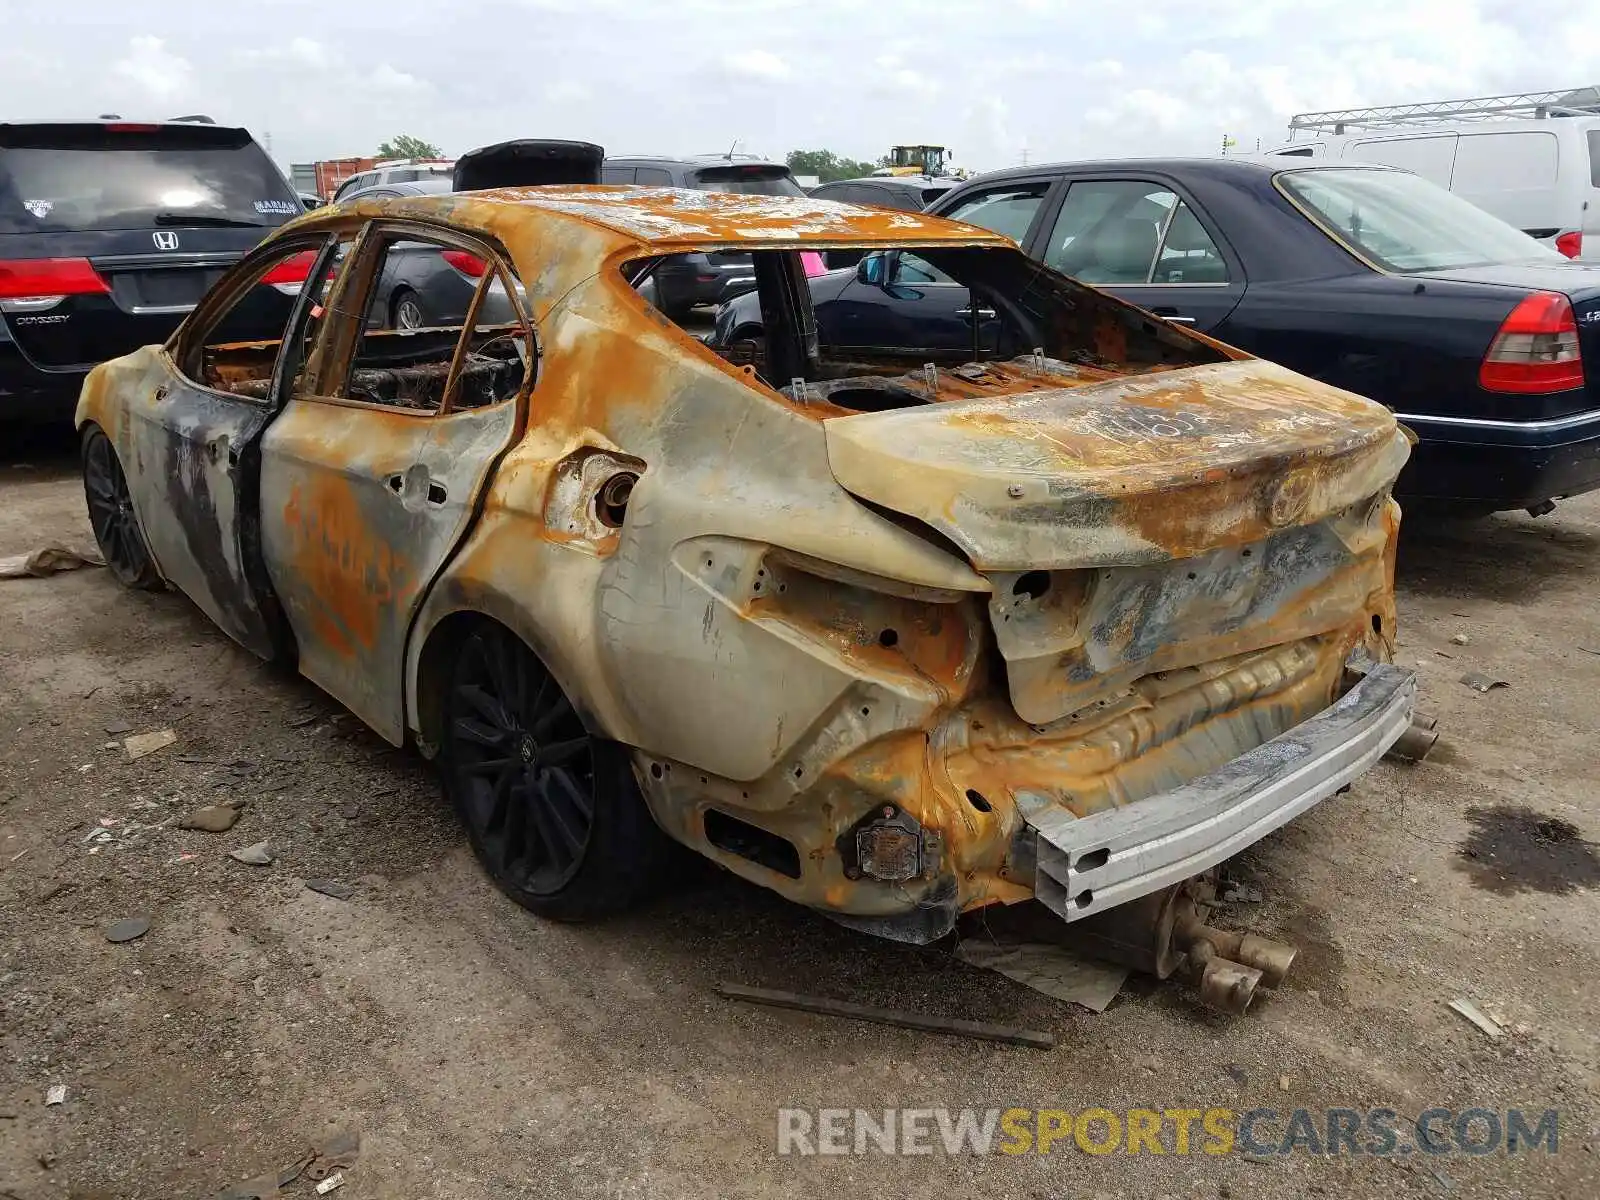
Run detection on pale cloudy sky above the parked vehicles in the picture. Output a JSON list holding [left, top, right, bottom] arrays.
[[0, 0, 1600, 170]]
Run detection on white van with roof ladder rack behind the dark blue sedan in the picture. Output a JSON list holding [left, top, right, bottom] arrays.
[[1267, 88, 1600, 261]]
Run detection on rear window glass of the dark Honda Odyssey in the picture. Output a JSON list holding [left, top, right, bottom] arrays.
[[0, 125, 304, 234]]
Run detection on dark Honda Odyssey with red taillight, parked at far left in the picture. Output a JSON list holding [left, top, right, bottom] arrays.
[[0, 120, 306, 421]]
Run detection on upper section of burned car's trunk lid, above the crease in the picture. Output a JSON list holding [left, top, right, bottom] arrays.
[[824, 358, 1410, 571]]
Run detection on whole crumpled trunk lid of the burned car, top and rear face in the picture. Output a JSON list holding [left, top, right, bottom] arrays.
[[826, 360, 1410, 726]]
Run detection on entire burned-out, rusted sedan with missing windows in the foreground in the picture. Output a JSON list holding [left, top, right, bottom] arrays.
[[78, 187, 1414, 960]]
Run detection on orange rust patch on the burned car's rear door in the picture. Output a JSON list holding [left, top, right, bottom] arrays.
[[283, 477, 414, 658]]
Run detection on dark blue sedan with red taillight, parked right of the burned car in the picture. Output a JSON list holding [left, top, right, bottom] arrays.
[[714, 158, 1600, 514]]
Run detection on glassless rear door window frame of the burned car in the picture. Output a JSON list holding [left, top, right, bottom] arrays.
[[296, 218, 544, 419]]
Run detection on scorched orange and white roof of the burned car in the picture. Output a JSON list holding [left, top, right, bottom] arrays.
[[317, 186, 1011, 250]]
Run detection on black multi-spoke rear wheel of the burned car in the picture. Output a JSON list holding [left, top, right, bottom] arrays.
[[442, 622, 670, 920]]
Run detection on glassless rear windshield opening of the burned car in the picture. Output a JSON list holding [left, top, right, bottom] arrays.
[[624, 246, 1227, 411]]
